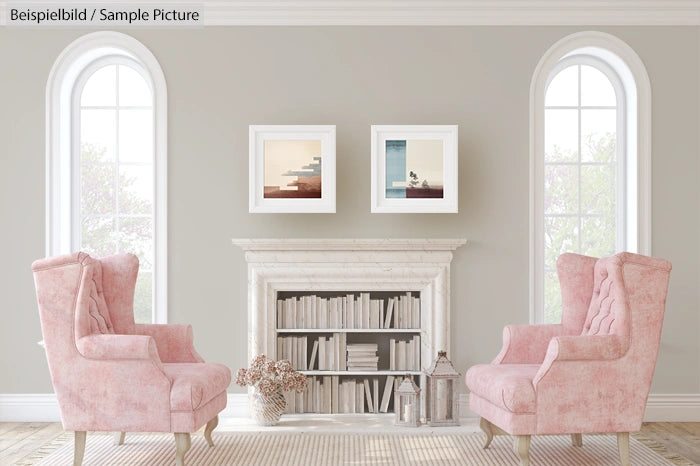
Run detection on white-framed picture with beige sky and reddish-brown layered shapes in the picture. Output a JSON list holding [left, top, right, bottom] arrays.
[[248, 125, 335, 213]]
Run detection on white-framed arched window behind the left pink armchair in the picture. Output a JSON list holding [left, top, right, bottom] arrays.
[[47, 32, 167, 322]]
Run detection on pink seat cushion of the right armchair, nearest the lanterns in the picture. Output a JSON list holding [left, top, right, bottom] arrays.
[[466, 364, 540, 414]]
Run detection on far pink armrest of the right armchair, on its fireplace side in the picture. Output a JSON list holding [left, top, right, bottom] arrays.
[[491, 324, 565, 364]]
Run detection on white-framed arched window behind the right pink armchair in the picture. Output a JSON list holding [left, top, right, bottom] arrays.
[[531, 32, 651, 323]]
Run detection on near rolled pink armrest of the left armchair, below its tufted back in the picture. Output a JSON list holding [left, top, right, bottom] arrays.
[[76, 333, 160, 365]]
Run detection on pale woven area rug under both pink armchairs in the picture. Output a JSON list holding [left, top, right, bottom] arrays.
[[32, 432, 678, 466]]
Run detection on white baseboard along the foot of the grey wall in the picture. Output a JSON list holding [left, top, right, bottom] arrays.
[[0, 393, 700, 422]]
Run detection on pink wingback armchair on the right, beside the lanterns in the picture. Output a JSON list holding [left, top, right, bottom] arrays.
[[466, 253, 671, 465]]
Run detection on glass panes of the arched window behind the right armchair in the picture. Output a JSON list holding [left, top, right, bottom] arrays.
[[542, 61, 624, 323]]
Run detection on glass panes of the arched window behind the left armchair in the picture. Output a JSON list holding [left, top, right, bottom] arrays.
[[80, 64, 154, 322]]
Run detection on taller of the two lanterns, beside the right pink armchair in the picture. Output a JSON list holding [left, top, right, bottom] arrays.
[[424, 351, 459, 426]]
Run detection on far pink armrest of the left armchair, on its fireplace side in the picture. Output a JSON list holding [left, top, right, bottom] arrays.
[[135, 324, 204, 363]]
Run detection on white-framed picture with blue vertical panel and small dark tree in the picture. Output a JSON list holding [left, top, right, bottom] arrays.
[[371, 125, 458, 213]]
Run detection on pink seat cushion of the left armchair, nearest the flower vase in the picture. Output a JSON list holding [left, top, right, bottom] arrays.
[[163, 363, 231, 412]]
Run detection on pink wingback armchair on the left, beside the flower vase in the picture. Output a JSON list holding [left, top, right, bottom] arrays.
[[32, 253, 231, 466]]
